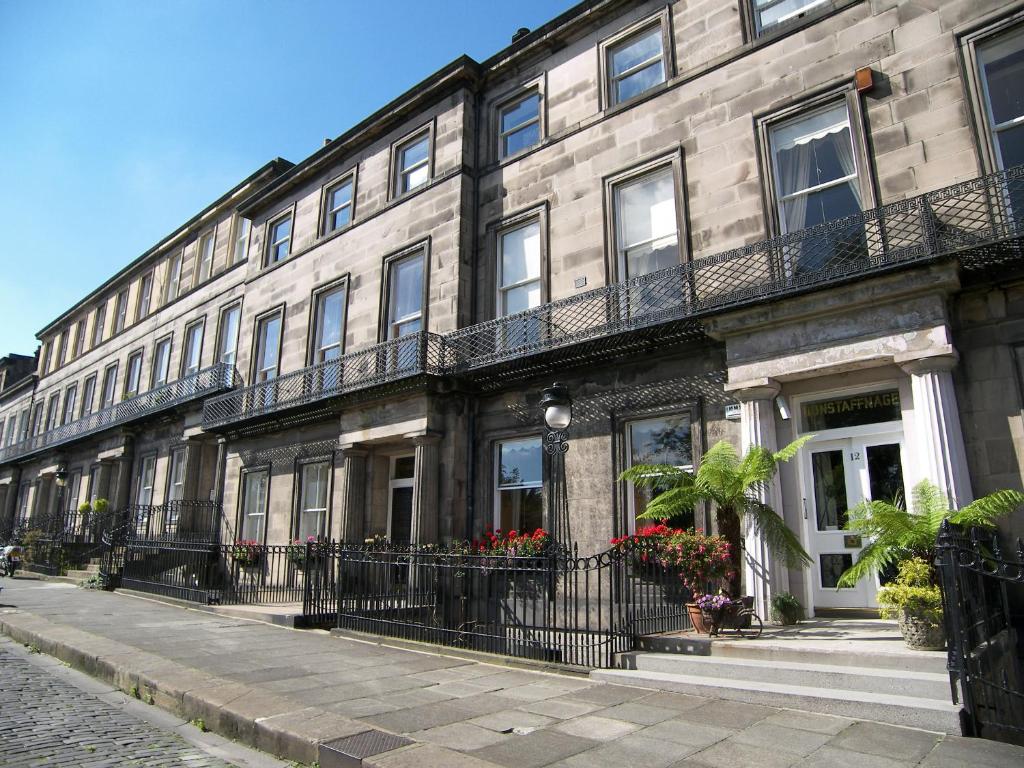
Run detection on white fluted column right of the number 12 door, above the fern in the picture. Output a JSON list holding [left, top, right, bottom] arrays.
[[896, 345, 974, 508]]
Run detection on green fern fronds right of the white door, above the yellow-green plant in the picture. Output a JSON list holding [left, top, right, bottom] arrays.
[[839, 480, 1024, 587]]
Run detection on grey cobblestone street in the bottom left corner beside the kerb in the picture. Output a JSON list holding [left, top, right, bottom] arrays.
[[0, 639, 288, 768]]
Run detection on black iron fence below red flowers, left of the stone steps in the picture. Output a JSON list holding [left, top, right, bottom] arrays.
[[323, 545, 690, 667]]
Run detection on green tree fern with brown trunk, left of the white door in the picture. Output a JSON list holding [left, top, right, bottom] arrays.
[[618, 435, 812, 597]]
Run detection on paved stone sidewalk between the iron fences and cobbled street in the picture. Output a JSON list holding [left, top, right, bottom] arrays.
[[0, 580, 1024, 768]]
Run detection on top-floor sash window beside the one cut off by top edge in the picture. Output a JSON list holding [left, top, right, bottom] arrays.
[[602, 20, 670, 105]]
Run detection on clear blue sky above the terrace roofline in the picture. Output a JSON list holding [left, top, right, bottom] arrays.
[[0, 0, 574, 355]]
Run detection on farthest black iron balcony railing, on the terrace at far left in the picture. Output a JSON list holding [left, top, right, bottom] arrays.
[[0, 362, 237, 464]]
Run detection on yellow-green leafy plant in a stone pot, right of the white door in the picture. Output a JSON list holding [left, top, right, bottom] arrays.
[[879, 557, 946, 650]]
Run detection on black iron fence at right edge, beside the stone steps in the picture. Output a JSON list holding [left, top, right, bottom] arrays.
[[936, 521, 1024, 745]]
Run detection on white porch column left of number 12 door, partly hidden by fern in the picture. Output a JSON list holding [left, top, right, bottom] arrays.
[[731, 379, 790, 616]]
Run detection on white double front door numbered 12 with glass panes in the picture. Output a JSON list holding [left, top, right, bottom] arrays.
[[803, 432, 904, 608]]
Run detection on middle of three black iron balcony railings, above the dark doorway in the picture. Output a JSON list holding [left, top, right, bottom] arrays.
[[203, 332, 451, 428]]
